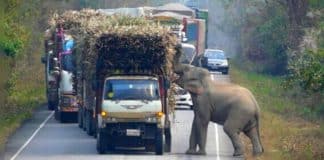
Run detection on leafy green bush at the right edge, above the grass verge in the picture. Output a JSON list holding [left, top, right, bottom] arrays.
[[286, 49, 324, 93]]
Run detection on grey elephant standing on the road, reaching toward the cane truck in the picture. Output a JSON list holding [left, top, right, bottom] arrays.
[[174, 63, 264, 156]]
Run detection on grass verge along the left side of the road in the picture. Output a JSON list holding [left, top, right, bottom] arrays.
[[0, 50, 45, 152]]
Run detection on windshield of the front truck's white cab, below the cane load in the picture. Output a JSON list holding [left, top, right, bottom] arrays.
[[104, 79, 159, 100]]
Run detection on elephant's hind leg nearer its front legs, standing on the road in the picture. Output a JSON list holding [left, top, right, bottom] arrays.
[[224, 120, 244, 156]]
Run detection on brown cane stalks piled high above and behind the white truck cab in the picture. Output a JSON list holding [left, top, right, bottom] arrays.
[[49, 9, 177, 111]]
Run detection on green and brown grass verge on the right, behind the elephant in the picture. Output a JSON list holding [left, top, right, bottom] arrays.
[[230, 67, 324, 160]]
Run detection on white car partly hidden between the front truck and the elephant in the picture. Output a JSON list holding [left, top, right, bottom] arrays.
[[175, 86, 193, 109]]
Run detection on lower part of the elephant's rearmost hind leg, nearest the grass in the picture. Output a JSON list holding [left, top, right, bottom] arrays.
[[244, 126, 263, 156]]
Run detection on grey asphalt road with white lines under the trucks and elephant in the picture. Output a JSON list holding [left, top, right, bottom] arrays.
[[4, 73, 240, 160]]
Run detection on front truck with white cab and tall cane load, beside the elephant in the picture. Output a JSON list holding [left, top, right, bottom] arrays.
[[96, 29, 175, 155]]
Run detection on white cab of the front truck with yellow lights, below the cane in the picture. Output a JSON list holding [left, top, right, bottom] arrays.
[[97, 75, 165, 154]]
